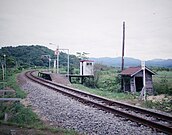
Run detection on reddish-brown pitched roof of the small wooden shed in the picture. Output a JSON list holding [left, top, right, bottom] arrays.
[[120, 67, 155, 77]]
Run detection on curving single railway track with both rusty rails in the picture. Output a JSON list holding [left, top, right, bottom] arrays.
[[25, 71, 172, 134]]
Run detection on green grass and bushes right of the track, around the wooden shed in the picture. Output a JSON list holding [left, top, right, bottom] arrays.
[[73, 70, 172, 113]]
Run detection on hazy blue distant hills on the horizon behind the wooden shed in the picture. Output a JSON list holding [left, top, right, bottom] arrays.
[[90, 57, 172, 68]]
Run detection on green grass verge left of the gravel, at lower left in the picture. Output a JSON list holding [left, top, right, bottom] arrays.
[[0, 71, 77, 135]]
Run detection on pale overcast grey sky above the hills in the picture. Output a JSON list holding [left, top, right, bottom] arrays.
[[0, 0, 172, 60]]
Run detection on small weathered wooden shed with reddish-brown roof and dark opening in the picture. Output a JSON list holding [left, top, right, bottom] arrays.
[[120, 66, 155, 94]]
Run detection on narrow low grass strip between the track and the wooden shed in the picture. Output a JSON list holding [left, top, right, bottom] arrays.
[[73, 84, 172, 113]]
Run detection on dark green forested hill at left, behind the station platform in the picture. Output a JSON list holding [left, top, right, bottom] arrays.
[[0, 45, 79, 68]]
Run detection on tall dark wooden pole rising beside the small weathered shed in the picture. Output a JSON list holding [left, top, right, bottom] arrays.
[[121, 22, 125, 90]]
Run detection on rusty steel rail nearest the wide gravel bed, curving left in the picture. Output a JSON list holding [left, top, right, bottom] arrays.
[[25, 71, 172, 134]]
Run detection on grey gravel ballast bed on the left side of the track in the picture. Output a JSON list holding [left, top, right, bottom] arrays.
[[18, 73, 164, 135]]
